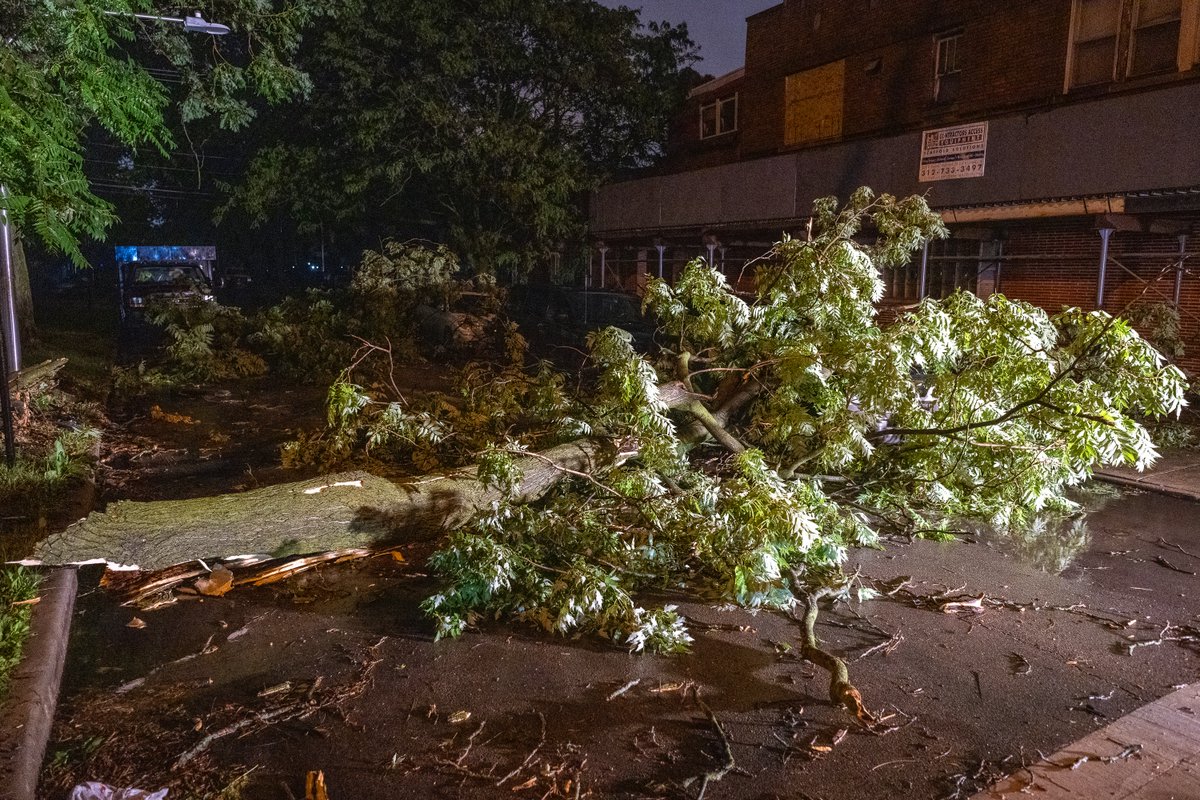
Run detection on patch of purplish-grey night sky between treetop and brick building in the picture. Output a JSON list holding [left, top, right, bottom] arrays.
[[600, 0, 782, 76]]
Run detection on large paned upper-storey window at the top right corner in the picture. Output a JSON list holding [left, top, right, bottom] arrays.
[[1067, 0, 1198, 89]]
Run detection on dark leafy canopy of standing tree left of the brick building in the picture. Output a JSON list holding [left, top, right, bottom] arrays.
[[223, 0, 695, 271]]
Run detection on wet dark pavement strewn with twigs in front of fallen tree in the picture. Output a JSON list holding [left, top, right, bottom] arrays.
[[43, 482, 1200, 800]]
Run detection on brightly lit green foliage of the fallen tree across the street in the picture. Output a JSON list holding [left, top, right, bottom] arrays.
[[312, 190, 1184, 657]]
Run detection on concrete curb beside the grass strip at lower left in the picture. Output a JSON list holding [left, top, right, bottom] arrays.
[[0, 567, 78, 800]]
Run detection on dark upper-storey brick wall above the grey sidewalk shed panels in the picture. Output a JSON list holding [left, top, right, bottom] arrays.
[[670, 0, 1070, 163]]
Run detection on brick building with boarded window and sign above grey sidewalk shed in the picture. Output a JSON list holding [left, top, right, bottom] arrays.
[[590, 0, 1200, 369]]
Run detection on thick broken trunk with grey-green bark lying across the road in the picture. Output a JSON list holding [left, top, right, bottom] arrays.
[[34, 439, 632, 570]]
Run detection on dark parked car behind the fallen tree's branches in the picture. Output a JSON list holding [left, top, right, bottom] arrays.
[[509, 284, 655, 350]]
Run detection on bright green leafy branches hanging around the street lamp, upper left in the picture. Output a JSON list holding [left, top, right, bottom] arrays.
[[0, 0, 335, 264]]
